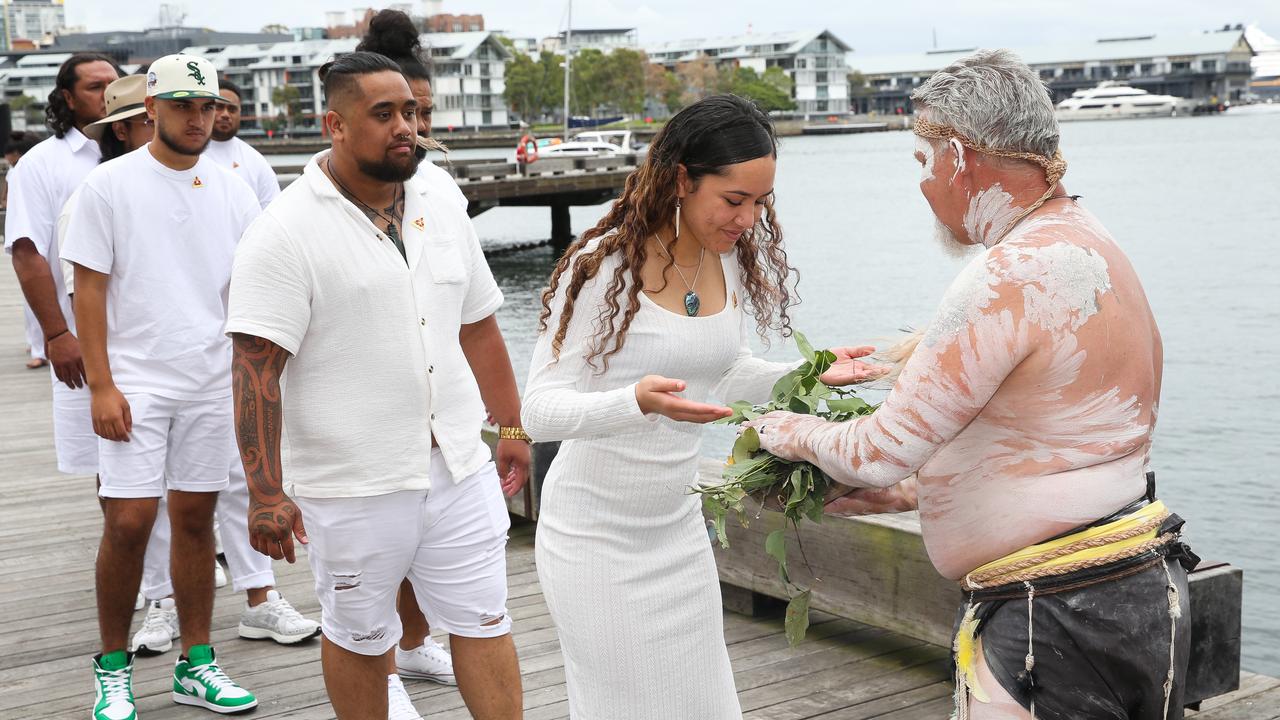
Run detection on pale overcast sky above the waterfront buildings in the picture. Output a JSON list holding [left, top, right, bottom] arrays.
[[67, 0, 1280, 58]]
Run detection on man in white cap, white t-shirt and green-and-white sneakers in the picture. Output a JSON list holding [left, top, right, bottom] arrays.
[[63, 54, 259, 720]]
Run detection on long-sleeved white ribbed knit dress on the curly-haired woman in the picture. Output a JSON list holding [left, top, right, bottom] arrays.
[[522, 242, 794, 720]]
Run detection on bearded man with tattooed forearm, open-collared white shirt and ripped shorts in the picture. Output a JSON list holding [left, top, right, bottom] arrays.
[[227, 51, 529, 720]]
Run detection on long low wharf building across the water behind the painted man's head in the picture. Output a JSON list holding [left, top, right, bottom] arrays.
[[849, 26, 1253, 114]]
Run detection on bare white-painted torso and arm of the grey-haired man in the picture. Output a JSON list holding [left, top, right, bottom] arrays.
[[788, 199, 1162, 578]]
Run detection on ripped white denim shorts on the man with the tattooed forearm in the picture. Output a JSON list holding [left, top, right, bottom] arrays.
[[294, 450, 511, 655]]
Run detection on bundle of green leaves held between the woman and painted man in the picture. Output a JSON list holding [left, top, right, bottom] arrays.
[[695, 332, 877, 646]]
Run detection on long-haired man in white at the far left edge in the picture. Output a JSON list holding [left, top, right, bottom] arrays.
[[4, 53, 120, 475]]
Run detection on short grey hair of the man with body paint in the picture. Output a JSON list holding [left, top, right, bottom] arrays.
[[911, 50, 1059, 158]]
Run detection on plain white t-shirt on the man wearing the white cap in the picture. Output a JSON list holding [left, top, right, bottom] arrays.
[[63, 145, 260, 400]]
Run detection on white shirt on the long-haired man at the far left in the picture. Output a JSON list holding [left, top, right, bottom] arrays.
[[4, 128, 102, 332]]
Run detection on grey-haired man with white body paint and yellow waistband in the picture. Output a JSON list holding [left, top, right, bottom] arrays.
[[751, 51, 1194, 719]]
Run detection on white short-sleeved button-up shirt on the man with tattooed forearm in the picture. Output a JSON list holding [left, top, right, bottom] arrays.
[[227, 151, 502, 497]]
